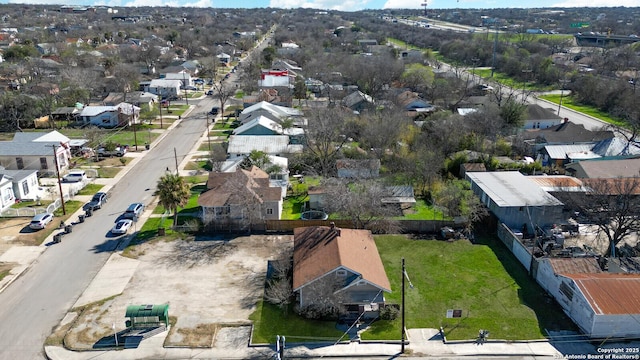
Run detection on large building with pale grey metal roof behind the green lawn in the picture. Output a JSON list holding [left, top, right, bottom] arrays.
[[466, 171, 565, 234]]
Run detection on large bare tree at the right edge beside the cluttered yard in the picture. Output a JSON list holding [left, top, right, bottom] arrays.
[[560, 176, 640, 257]]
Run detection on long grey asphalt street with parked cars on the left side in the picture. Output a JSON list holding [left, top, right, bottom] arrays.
[[0, 97, 219, 359]]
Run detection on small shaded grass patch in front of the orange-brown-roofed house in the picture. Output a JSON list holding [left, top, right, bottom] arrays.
[[249, 301, 342, 344]]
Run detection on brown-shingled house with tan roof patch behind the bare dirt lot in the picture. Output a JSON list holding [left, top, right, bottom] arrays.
[[198, 166, 282, 230]]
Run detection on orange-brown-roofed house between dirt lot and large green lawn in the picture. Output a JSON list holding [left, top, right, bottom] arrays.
[[293, 224, 391, 317]]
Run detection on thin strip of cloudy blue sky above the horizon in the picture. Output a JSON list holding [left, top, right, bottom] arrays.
[[0, 0, 640, 11]]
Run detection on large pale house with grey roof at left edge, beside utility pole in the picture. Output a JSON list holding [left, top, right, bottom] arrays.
[[0, 131, 71, 175]]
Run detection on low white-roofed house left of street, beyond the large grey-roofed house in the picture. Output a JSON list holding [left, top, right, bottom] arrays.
[[77, 103, 140, 128]]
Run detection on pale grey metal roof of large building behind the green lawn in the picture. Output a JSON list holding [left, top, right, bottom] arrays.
[[466, 171, 562, 207]]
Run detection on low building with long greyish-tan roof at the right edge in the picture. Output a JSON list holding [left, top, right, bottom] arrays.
[[565, 157, 640, 179]]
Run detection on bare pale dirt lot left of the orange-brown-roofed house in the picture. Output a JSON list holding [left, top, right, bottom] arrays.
[[65, 235, 293, 349]]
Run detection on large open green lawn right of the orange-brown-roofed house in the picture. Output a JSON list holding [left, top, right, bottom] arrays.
[[363, 235, 575, 340]]
